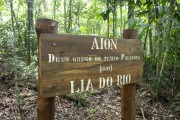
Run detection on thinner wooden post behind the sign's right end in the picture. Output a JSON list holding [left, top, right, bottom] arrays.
[[121, 29, 137, 120]]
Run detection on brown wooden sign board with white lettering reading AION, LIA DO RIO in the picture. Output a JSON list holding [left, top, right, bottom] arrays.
[[39, 34, 143, 97]]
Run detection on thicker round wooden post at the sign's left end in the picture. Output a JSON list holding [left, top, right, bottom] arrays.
[[36, 18, 58, 120]]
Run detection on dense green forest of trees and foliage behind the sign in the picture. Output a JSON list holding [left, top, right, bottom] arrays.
[[0, 0, 180, 118]]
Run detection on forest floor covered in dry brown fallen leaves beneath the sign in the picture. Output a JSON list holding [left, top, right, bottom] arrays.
[[0, 81, 180, 120]]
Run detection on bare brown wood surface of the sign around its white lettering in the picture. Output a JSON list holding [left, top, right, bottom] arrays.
[[39, 34, 143, 97]]
